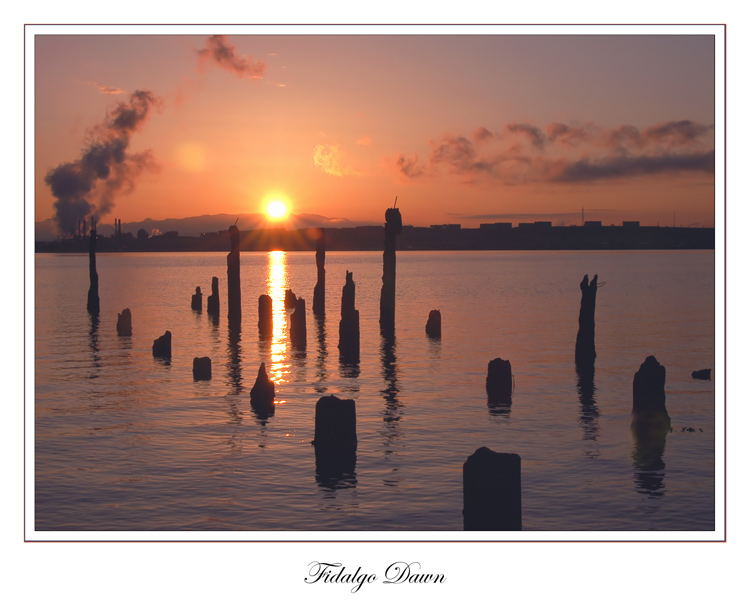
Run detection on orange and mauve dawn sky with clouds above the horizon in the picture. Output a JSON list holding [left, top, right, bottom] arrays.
[[33, 28, 723, 232]]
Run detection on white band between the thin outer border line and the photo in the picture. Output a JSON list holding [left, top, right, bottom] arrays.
[[24, 25, 726, 543]]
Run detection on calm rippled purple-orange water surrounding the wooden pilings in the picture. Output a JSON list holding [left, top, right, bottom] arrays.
[[34, 252, 715, 538]]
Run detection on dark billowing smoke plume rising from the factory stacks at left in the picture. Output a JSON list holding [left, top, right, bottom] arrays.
[[44, 90, 160, 234]]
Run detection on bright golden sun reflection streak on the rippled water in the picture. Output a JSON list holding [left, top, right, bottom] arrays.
[[266, 251, 292, 384]]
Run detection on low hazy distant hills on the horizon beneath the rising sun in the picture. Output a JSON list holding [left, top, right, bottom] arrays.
[[34, 213, 381, 241]]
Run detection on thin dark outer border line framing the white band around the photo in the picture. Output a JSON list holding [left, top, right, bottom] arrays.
[[23, 23, 728, 543]]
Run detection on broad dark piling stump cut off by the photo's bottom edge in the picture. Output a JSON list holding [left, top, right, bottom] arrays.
[[463, 447, 522, 531]]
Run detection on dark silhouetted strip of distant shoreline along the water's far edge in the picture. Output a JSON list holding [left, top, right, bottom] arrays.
[[35, 223, 715, 253]]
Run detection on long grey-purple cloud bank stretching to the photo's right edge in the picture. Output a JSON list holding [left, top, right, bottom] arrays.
[[392, 120, 714, 184]]
